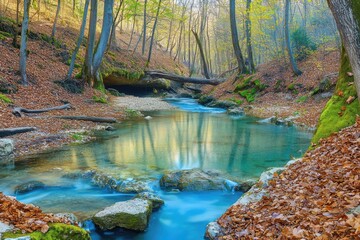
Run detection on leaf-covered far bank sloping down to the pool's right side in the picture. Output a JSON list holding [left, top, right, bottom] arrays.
[[203, 47, 340, 128]]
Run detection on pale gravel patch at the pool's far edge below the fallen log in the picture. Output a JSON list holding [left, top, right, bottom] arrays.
[[114, 96, 175, 111]]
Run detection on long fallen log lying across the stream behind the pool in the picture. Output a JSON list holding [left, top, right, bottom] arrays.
[[145, 70, 224, 85]]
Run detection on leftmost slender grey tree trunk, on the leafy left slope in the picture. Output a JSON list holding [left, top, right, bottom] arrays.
[[20, 0, 30, 86]]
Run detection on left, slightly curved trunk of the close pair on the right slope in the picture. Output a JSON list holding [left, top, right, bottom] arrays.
[[230, 0, 247, 73]]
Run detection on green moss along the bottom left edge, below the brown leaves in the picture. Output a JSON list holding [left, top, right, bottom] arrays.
[[3, 223, 91, 240]]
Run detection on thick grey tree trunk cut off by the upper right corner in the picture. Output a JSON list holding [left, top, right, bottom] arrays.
[[328, 0, 360, 101]]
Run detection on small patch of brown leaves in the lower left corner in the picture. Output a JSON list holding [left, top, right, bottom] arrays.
[[0, 192, 70, 233]]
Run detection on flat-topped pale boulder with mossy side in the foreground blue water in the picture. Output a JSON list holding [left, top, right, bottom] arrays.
[[93, 198, 152, 231]]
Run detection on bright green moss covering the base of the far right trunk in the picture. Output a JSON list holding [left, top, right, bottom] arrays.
[[312, 49, 360, 143]]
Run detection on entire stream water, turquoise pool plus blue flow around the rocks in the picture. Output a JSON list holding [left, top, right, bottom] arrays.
[[0, 99, 312, 240]]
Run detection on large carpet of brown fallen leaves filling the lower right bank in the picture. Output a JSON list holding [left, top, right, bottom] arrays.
[[218, 118, 360, 240]]
